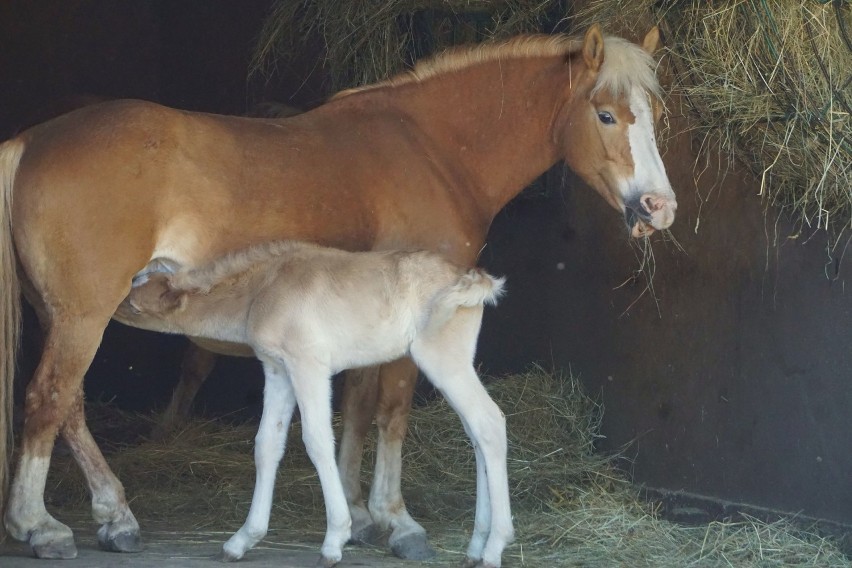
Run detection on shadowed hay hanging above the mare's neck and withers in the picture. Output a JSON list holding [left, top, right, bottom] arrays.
[[251, 0, 564, 94]]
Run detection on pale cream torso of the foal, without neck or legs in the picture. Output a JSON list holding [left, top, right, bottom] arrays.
[[247, 248, 466, 372]]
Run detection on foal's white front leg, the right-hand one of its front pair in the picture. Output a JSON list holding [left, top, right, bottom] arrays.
[[290, 362, 352, 567]]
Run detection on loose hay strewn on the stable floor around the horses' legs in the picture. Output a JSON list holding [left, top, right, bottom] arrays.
[[41, 369, 849, 568]]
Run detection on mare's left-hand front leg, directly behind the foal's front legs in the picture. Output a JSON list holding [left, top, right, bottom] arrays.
[[337, 367, 381, 544]]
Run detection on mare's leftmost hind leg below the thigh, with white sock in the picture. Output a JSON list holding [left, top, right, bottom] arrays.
[[5, 314, 115, 558]]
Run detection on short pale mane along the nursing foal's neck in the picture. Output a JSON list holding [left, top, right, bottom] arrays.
[[171, 241, 326, 294]]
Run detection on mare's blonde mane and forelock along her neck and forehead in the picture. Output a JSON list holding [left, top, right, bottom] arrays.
[[333, 34, 660, 99]]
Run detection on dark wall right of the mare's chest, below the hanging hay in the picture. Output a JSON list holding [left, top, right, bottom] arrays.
[[480, 105, 852, 523]]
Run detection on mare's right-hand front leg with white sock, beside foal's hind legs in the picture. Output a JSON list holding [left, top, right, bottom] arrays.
[[370, 359, 435, 560]]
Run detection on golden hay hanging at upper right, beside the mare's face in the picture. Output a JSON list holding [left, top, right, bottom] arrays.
[[579, 0, 852, 237]]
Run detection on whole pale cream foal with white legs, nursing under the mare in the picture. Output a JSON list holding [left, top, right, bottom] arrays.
[[119, 241, 513, 567]]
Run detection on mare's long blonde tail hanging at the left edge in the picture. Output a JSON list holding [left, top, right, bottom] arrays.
[[0, 138, 24, 524]]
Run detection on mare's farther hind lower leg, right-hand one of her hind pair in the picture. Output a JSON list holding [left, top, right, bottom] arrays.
[[61, 392, 142, 552]]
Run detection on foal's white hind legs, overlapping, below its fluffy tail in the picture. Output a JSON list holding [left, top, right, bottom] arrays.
[[411, 308, 514, 567]]
